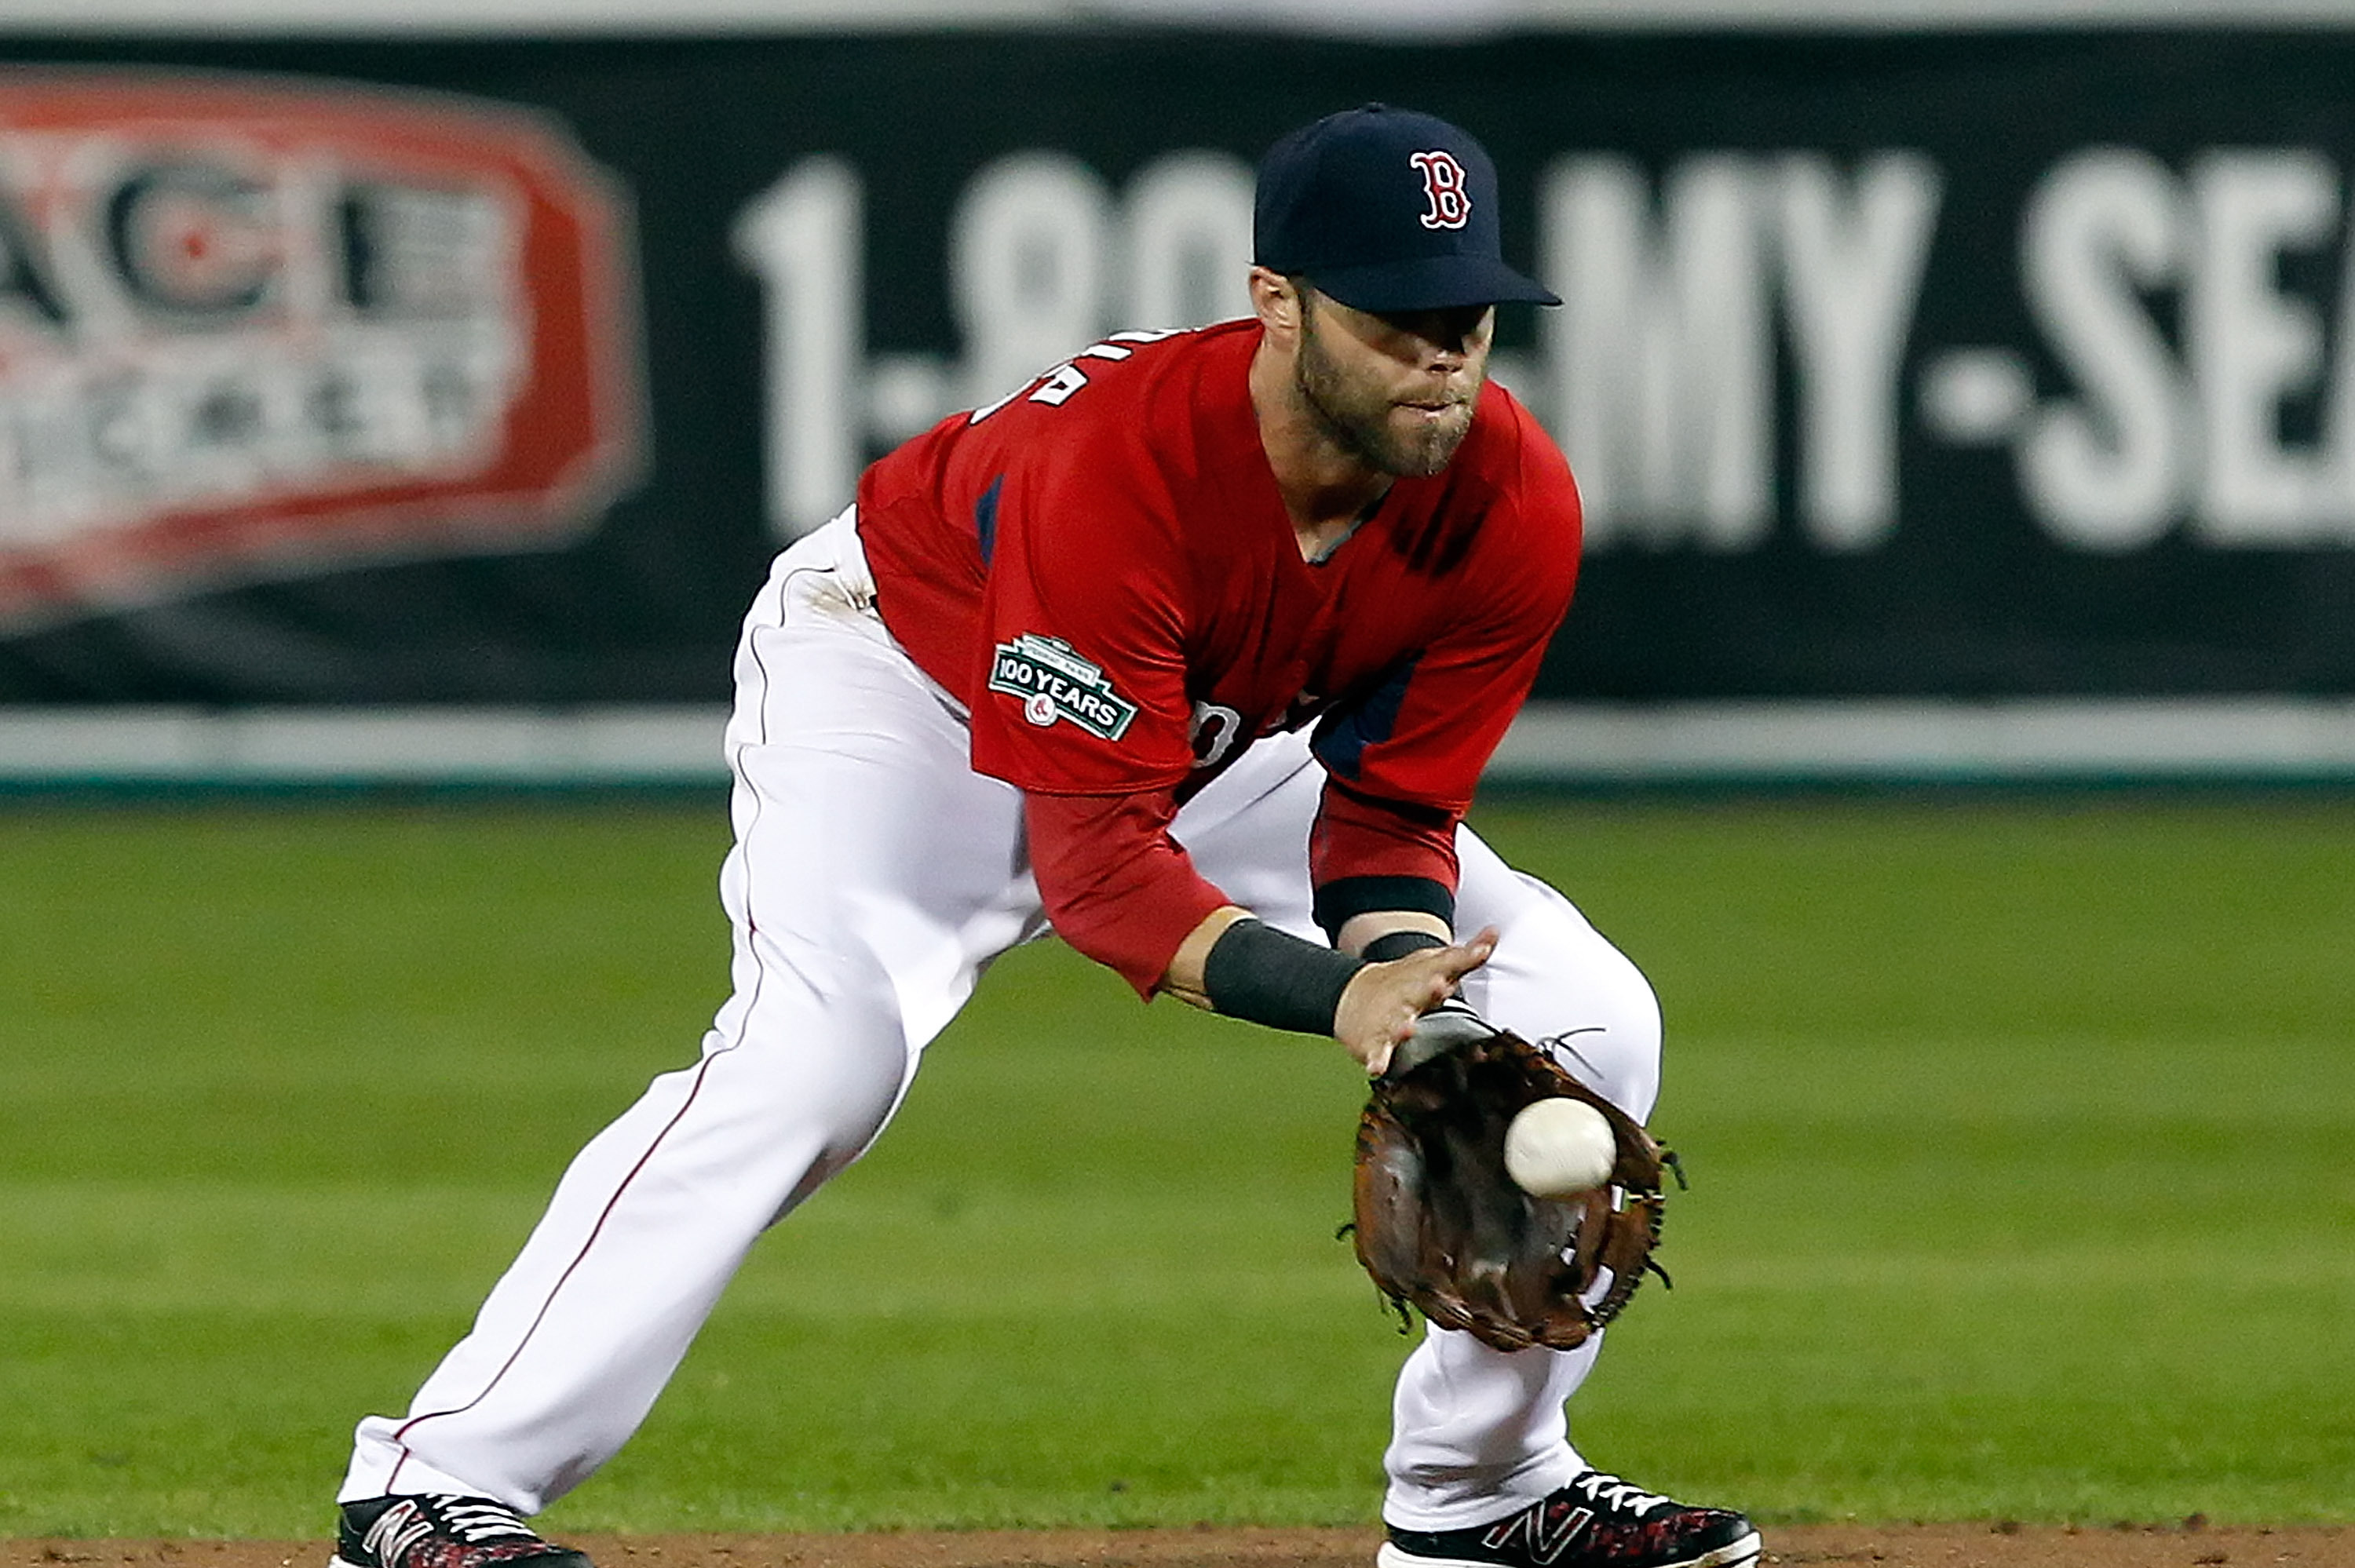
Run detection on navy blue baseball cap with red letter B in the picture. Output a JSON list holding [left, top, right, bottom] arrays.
[[1251, 104, 1561, 313]]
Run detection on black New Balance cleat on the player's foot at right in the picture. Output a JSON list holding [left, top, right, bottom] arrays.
[[1375, 1469, 1762, 1568]]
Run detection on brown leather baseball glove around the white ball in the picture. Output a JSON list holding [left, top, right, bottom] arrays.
[[1354, 1010, 1681, 1351]]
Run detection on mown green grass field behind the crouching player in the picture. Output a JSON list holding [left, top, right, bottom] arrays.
[[0, 796, 2355, 1537]]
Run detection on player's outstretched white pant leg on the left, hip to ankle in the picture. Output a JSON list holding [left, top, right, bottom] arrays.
[[341, 518, 1039, 1516]]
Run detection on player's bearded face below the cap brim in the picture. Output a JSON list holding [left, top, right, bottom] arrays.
[[1293, 292, 1495, 478]]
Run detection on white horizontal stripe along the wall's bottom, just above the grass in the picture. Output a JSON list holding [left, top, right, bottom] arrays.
[[0, 697, 2355, 789]]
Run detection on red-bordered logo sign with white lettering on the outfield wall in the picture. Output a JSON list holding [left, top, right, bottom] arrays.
[[0, 71, 643, 626]]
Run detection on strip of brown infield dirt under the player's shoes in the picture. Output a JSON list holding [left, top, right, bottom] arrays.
[[0, 1519, 2355, 1568]]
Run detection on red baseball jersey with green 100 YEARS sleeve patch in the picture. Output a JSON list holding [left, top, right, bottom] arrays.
[[857, 320, 1578, 989]]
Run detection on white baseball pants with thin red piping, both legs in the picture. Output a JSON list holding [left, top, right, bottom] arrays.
[[339, 511, 1660, 1530]]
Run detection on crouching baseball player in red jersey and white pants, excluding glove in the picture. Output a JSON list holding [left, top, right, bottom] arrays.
[[334, 104, 1759, 1568]]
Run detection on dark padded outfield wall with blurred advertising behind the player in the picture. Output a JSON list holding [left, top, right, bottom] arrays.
[[0, 15, 2355, 784]]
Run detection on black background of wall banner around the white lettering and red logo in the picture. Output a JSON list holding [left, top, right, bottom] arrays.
[[0, 31, 2355, 704]]
